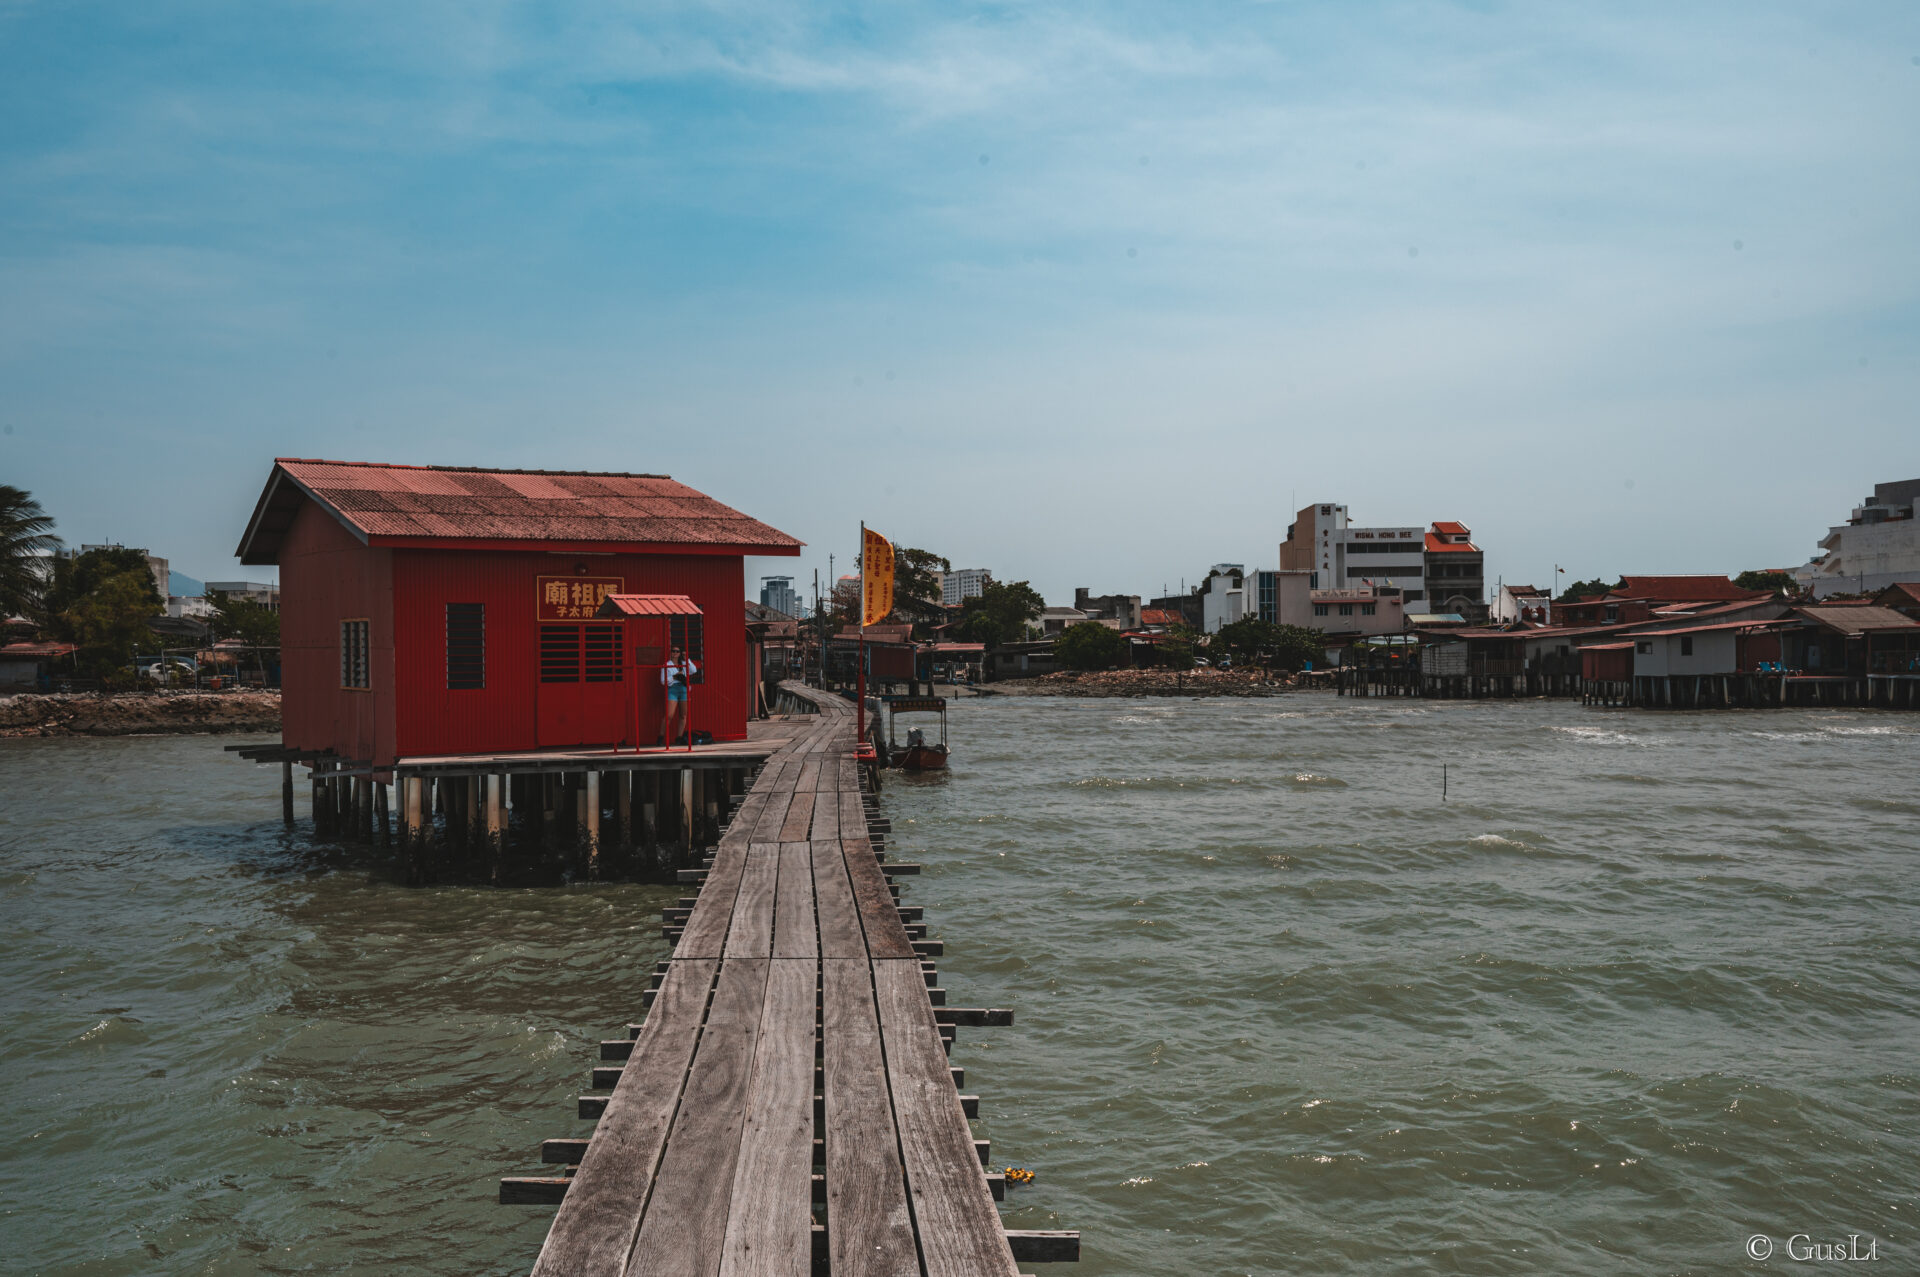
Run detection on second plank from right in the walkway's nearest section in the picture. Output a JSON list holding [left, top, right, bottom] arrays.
[[820, 960, 920, 1277]]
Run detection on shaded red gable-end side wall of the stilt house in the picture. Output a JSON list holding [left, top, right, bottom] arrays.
[[280, 503, 394, 764]]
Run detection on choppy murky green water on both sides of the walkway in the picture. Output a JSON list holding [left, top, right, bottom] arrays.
[[0, 695, 1920, 1277]]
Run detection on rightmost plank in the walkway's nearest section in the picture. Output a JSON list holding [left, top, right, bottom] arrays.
[[870, 962, 1020, 1277]]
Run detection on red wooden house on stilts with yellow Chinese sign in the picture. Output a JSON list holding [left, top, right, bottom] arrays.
[[238, 457, 801, 770]]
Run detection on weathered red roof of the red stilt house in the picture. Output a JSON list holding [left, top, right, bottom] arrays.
[[240, 457, 801, 565]]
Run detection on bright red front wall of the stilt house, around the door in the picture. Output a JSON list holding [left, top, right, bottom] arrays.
[[392, 549, 749, 757]]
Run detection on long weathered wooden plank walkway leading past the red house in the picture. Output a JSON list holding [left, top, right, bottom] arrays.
[[501, 684, 1079, 1277]]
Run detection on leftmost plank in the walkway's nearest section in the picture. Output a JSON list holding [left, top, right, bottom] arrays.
[[534, 960, 720, 1277]]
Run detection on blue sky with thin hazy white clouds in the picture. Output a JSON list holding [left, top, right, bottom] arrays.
[[0, 0, 1920, 603]]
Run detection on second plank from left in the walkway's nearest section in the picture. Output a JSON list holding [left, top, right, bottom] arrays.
[[633, 958, 768, 1277]]
